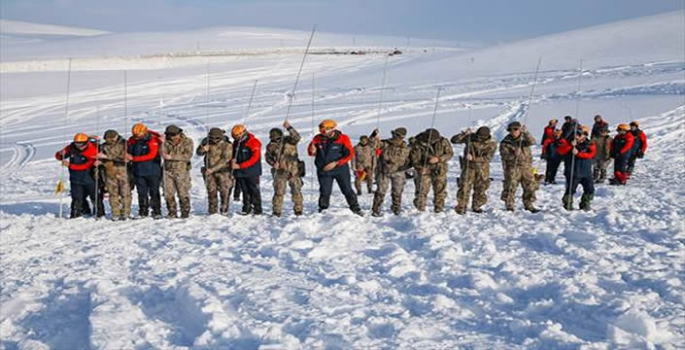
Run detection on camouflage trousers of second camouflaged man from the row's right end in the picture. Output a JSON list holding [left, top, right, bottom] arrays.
[[455, 166, 490, 213]]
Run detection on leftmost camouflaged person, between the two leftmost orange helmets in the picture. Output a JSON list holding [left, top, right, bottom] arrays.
[[98, 129, 131, 221]]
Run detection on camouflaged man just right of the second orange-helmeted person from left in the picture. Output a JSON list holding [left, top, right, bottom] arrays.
[[162, 125, 193, 218]]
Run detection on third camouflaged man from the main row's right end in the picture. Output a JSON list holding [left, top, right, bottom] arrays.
[[409, 129, 454, 213]]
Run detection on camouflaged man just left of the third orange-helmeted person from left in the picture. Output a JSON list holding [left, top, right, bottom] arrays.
[[195, 128, 233, 215]]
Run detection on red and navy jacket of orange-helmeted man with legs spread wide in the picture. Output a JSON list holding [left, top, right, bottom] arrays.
[[307, 130, 354, 176]]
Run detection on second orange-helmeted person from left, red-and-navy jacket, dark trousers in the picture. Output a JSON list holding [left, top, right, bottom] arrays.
[[126, 123, 162, 219]]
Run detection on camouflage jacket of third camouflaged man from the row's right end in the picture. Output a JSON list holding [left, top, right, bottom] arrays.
[[409, 134, 454, 175]]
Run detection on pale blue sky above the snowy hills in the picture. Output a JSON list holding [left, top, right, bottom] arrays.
[[0, 0, 685, 43]]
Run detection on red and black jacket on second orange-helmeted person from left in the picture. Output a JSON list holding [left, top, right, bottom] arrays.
[[126, 130, 163, 177]]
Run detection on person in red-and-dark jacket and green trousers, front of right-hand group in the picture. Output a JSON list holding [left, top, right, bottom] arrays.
[[557, 126, 597, 211]]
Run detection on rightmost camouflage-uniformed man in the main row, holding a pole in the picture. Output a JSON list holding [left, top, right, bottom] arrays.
[[499, 122, 539, 213]]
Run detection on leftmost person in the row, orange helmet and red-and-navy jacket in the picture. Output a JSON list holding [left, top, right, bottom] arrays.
[[55, 133, 98, 219]]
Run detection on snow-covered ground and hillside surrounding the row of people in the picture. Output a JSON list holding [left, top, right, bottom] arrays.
[[0, 12, 685, 349]]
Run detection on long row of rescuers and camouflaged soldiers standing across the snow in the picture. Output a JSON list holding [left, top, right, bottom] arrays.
[[55, 116, 647, 220]]
